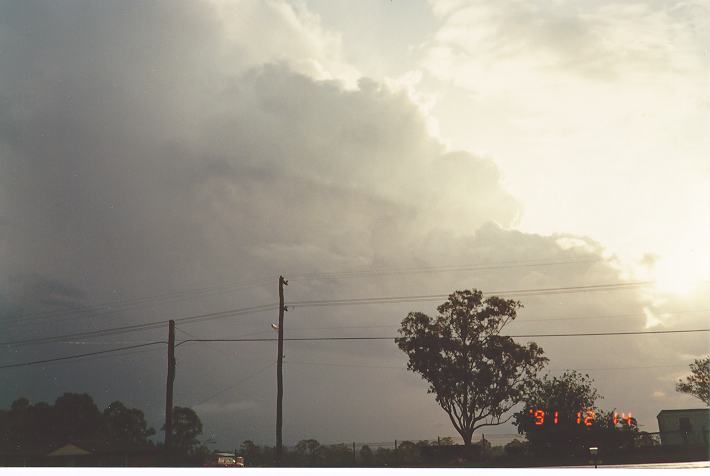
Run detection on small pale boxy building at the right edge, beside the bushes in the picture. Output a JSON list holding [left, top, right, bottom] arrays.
[[657, 408, 710, 446]]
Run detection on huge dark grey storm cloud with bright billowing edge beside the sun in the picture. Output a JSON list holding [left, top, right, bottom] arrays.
[[0, 2, 707, 447]]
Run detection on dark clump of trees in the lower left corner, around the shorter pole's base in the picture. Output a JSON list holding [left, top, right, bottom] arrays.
[[0, 393, 210, 466]]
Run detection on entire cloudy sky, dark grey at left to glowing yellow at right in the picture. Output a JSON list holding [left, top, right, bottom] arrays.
[[0, 0, 710, 448]]
